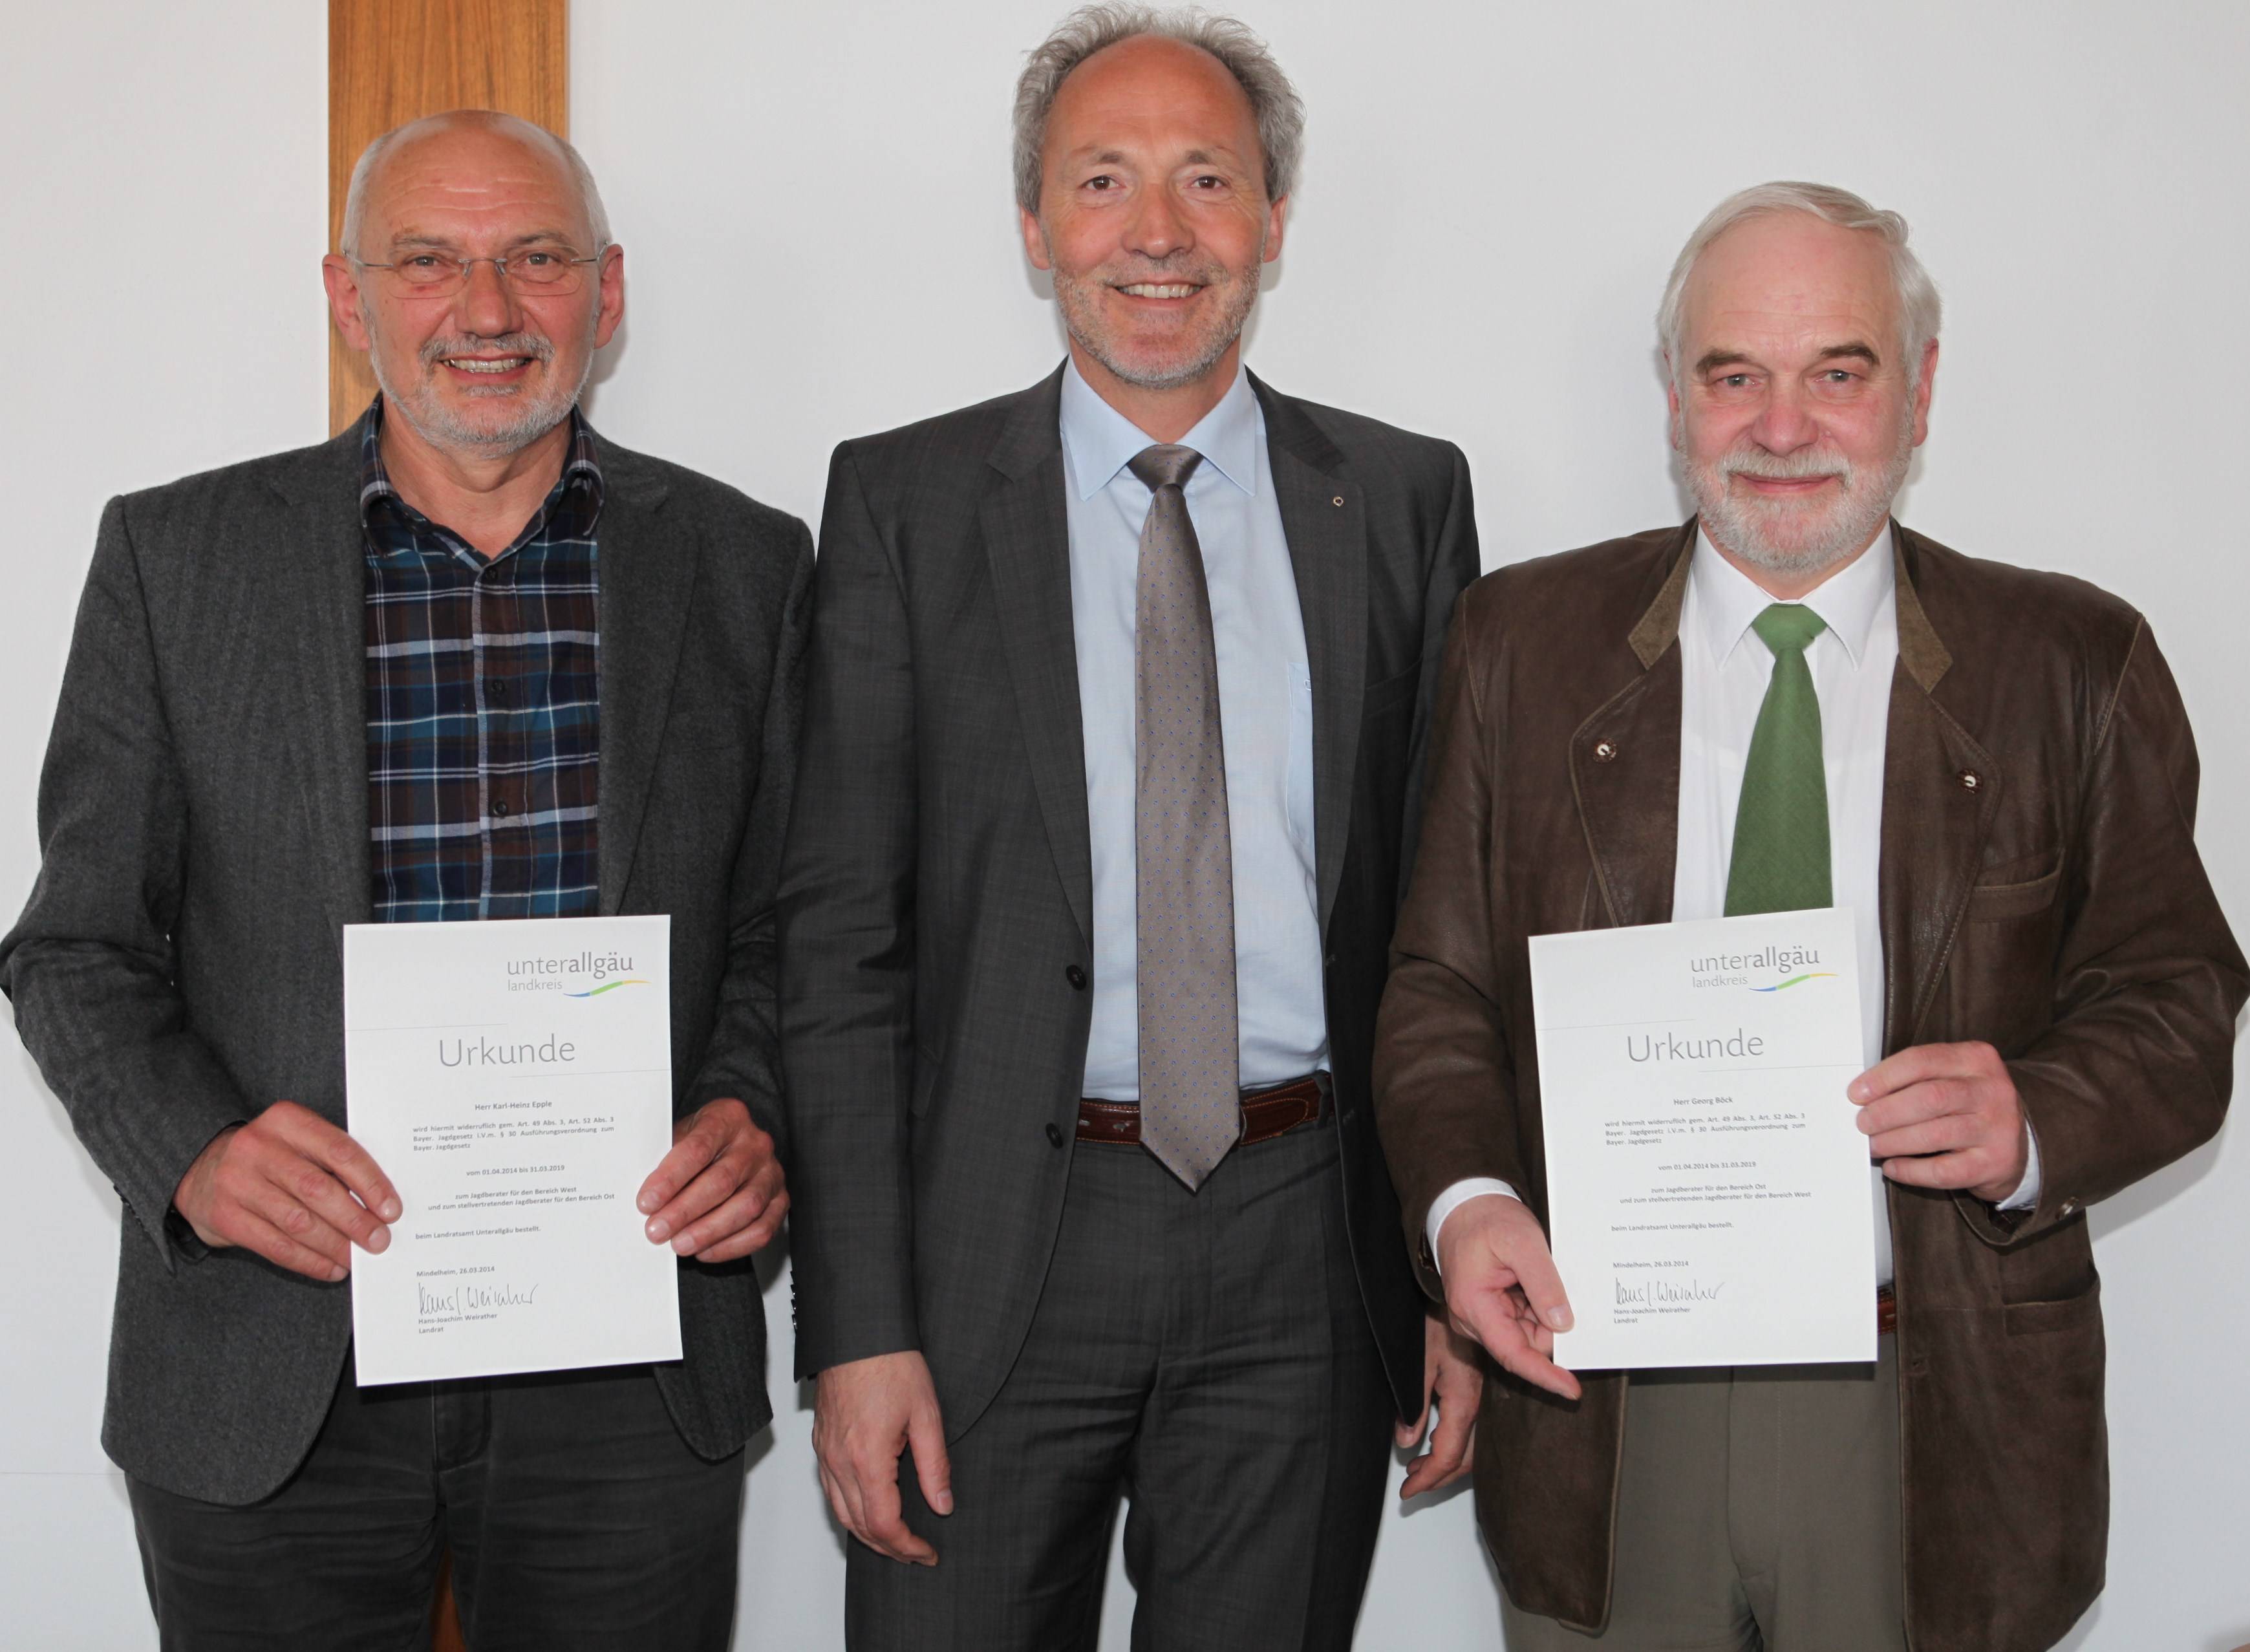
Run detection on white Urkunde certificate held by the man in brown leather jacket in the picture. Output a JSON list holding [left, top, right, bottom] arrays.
[[1530, 909, 1874, 1371]]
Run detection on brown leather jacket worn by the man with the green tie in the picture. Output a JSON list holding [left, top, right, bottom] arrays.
[[1375, 522, 2250, 1652]]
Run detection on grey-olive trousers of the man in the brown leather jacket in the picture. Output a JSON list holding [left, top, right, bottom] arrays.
[[1503, 1335, 1906, 1652]]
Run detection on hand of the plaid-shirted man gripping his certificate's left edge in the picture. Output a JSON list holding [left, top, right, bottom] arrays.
[[171, 1100, 400, 1283]]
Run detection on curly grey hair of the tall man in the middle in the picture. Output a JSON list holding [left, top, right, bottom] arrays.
[[1014, 0, 1305, 216]]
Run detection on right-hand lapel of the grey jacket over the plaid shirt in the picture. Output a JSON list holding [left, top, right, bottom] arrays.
[[596, 444, 679, 916]]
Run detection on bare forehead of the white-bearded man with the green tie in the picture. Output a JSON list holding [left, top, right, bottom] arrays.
[[1681, 214, 1899, 360]]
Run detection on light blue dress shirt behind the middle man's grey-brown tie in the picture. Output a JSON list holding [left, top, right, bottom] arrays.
[[1062, 362, 1327, 1100]]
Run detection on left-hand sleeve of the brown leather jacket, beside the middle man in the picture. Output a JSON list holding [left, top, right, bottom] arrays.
[[1375, 581, 1528, 1298]]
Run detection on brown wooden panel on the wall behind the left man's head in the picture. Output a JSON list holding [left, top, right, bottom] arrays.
[[328, 0, 569, 434]]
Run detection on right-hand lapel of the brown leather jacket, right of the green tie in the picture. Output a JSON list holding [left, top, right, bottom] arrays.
[[1876, 537, 2002, 1053]]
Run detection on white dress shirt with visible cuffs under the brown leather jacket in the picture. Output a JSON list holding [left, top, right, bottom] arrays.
[[1424, 537, 2039, 1285]]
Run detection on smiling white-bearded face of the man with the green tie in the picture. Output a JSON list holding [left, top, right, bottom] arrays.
[[1667, 211, 1937, 596]]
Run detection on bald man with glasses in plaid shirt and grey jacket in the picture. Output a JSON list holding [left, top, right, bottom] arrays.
[[0, 113, 810, 1652]]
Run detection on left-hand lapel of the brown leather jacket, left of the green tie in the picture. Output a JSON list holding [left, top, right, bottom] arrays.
[[1570, 522, 1694, 927]]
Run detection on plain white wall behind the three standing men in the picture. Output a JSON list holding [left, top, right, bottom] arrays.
[[0, 0, 2250, 1652]]
